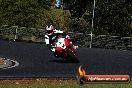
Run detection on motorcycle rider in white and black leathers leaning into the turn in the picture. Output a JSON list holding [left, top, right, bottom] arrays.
[[45, 24, 78, 58]]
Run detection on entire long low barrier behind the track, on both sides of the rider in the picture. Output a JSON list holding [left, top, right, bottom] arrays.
[[0, 25, 132, 51]]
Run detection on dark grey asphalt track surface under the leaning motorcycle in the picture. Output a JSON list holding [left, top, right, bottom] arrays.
[[0, 40, 132, 78]]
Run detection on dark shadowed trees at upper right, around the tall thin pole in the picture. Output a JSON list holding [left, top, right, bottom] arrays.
[[64, 0, 132, 36]]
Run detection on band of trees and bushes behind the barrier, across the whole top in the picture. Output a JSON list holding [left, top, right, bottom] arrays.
[[0, 0, 132, 36]]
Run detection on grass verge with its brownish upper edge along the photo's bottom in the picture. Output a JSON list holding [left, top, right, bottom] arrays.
[[0, 80, 132, 88]]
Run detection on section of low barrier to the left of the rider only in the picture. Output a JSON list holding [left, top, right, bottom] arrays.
[[0, 25, 45, 42]]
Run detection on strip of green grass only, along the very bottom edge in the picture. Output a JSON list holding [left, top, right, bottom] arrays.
[[0, 82, 132, 88]]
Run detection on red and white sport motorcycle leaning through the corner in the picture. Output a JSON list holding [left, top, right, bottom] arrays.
[[54, 35, 79, 62]]
